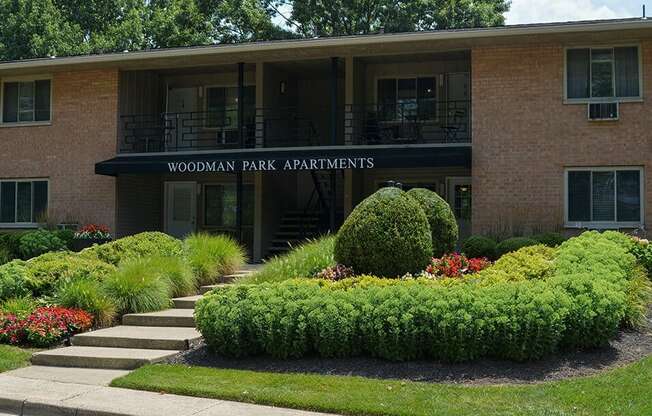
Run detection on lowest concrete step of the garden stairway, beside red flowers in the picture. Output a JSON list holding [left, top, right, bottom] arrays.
[[32, 346, 180, 370]]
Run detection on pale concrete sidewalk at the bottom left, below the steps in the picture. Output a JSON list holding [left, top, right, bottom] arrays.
[[0, 370, 334, 416]]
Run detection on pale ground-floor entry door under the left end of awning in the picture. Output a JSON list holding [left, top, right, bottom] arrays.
[[165, 182, 197, 238]]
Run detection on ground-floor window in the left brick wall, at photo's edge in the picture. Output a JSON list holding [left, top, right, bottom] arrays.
[[0, 180, 48, 224]]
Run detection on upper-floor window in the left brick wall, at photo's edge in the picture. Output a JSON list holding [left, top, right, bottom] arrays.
[[2, 79, 51, 123]]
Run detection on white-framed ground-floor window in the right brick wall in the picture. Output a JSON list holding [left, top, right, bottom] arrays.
[[564, 167, 644, 228]]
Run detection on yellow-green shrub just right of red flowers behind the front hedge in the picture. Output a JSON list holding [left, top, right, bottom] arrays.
[[491, 245, 555, 280]]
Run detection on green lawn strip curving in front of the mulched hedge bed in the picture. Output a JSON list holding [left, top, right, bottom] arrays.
[[112, 357, 652, 416]]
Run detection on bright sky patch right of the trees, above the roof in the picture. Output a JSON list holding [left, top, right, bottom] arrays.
[[505, 0, 652, 25]]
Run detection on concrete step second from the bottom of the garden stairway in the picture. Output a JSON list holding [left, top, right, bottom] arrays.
[[72, 326, 201, 350]]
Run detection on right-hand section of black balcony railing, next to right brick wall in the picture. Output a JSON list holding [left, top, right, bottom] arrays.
[[346, 100, 471, 145]]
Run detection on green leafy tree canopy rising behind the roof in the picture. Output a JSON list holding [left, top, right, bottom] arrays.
[[0, 0, 509, 60]]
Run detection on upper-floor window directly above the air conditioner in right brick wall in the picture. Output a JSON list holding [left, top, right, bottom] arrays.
[[566, 46, 641, 100]]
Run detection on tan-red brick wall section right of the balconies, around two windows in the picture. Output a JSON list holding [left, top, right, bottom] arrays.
[[472, 41, 652, 237]]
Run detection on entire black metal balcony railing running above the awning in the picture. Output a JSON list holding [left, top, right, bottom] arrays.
[[118, 101, 471, 153]]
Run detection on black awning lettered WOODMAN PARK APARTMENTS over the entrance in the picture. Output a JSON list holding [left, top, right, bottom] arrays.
[[95, 145, 471, 176]]
